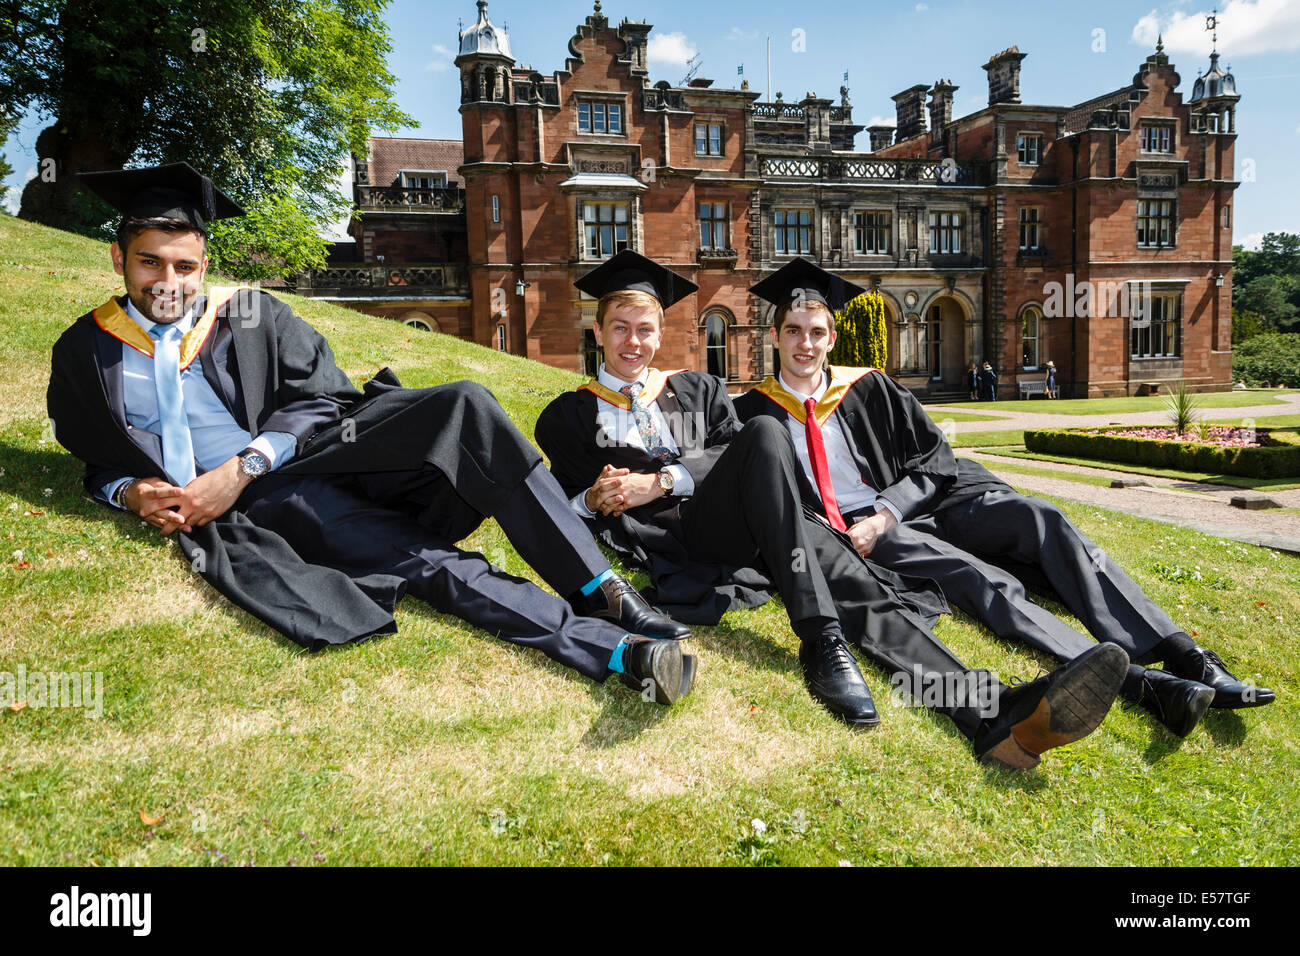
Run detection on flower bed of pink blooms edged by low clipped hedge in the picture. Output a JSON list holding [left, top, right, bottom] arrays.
[[1024, 425, 1300, 477]]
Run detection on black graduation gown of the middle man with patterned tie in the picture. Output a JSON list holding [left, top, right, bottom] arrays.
[[533, 372, 774, 624]]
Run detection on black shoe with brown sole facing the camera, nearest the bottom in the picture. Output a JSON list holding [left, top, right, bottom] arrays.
[[975, 644, 1128, 770]]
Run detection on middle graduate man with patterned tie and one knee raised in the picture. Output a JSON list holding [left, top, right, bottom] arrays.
[[536, 252, 1122, 767]]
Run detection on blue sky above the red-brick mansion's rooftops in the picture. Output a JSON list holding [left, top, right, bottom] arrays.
[[5, 0, 1300, 245]]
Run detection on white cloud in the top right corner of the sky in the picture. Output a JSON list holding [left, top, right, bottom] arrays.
[[1130, 0, 1300, 56]]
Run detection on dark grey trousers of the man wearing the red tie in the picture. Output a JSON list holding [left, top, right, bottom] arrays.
[[871, 492, 1179, 661]]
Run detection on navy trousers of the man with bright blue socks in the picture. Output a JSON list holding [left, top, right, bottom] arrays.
[[244, 464, 624, 682]]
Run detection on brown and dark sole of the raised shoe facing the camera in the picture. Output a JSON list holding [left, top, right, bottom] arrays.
[[991, 644, 1128, 757]]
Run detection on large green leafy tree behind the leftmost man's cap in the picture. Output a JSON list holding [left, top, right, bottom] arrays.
[[0, 0, 413, 278]]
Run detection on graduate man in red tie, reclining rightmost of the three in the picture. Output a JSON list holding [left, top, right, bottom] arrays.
[[735, 259, 1273, 736]]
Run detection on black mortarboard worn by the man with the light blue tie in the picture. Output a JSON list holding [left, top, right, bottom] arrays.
[[77, 163, 244, 232]]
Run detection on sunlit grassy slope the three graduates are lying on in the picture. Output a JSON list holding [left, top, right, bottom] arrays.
[[0, 216, 1300, 865]]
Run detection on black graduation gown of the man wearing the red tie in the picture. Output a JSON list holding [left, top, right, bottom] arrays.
[[733, 367, 1010, 520]]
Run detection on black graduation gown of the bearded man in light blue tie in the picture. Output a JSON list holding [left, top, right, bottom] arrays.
[[47, 289, 541, 649]]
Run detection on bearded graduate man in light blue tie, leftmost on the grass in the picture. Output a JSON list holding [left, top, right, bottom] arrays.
[[48, 163, 694, 702]]
